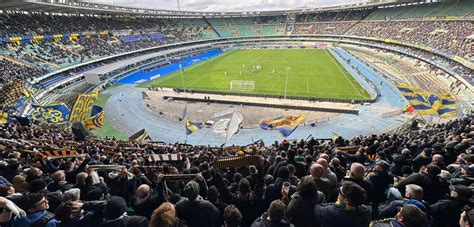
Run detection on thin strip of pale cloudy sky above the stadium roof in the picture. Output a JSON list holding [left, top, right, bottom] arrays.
[[83, 0, 367, 12]]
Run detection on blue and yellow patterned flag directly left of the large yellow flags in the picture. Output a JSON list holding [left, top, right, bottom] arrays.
[[31, 104, 71, 124]]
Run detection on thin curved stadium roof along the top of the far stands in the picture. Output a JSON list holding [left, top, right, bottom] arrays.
[[0, 0, 422, 17]]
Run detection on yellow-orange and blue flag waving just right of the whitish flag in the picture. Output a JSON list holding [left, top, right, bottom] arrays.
[[260, 115, 306, 138]]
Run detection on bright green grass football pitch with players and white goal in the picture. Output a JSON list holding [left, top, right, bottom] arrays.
[[141, 49, 370, 100]]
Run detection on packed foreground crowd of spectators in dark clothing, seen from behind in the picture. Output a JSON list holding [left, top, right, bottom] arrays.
[[0, 107, 474, 227]]
